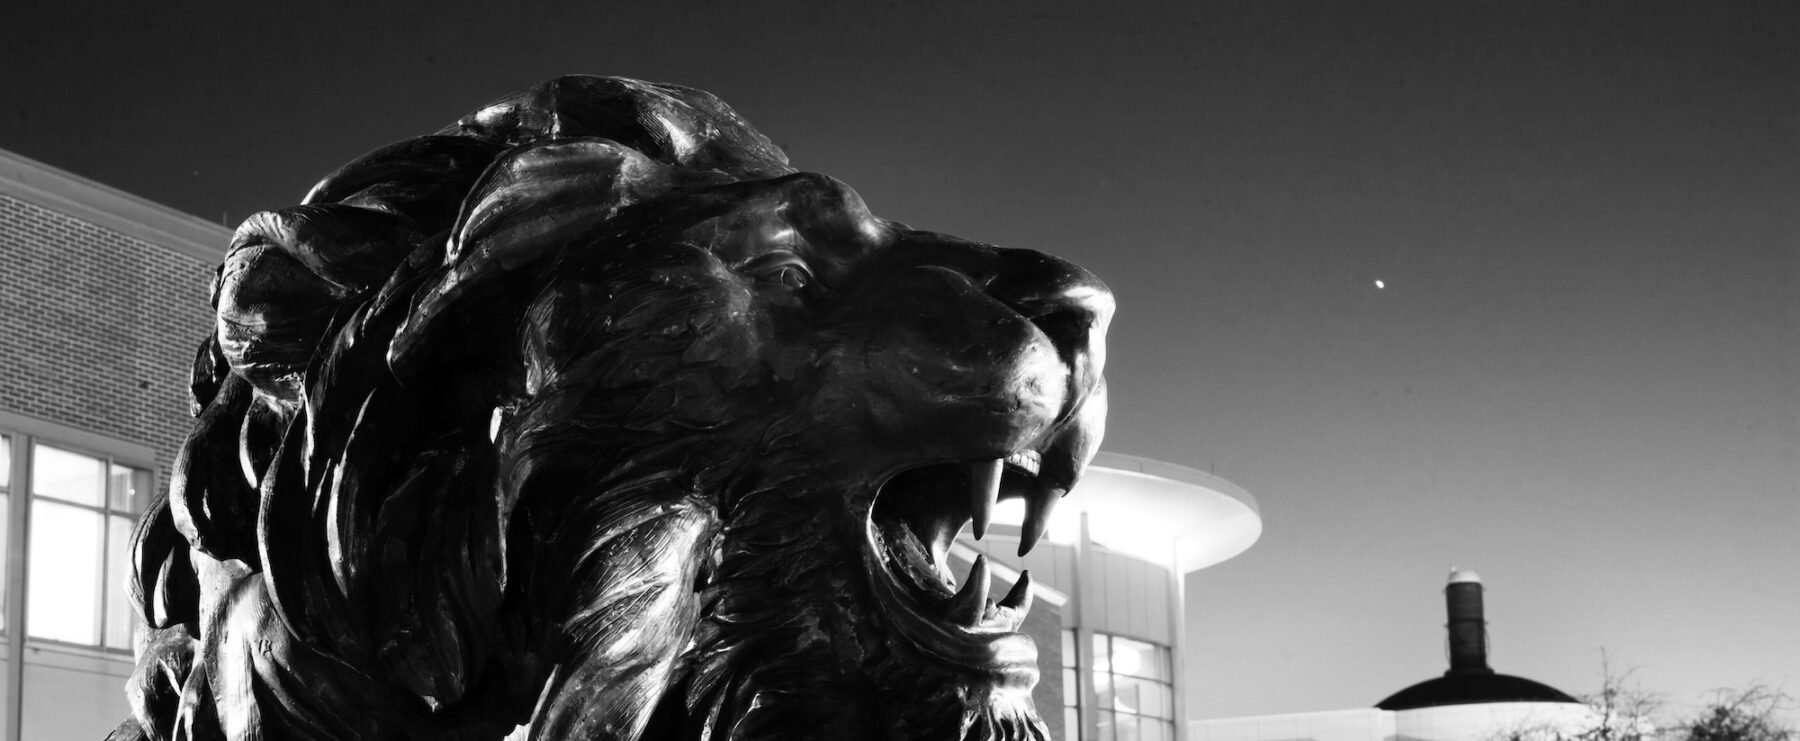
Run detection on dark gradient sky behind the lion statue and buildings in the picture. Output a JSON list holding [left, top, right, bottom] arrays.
[[0, 2, 1800, 726]]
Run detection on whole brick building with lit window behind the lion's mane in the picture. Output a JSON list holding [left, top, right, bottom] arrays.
[[0, 151, 230, 741]]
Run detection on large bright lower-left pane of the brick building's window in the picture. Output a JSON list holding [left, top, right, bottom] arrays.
[[25, 499, 104, 644]]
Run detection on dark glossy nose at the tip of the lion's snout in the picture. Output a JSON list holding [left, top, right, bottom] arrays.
[[986, 250, 1114, 376]]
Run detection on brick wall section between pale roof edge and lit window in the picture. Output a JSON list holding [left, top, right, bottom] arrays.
[[0, 194, 225, 467]]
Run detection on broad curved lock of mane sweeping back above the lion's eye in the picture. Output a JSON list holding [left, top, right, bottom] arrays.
[[389, 138, 689, 381]]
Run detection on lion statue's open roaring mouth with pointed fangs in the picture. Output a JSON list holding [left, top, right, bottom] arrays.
[[869, 450, 1067, 635]]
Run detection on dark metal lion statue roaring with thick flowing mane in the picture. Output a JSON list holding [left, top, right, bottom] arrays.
[[112, 76, 1112, 741]]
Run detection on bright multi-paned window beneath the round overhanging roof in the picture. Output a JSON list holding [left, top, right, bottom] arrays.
[[1093, 633, 1175, 741]]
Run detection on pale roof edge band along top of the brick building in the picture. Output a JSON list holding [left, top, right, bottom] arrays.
[[0, 149, 232, 263]]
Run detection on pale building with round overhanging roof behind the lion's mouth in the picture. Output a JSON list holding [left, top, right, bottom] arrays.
[[952, 453, 1262, 741]]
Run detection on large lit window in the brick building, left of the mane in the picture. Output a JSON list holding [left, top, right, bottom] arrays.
[[25, 444, 151, 649]]
